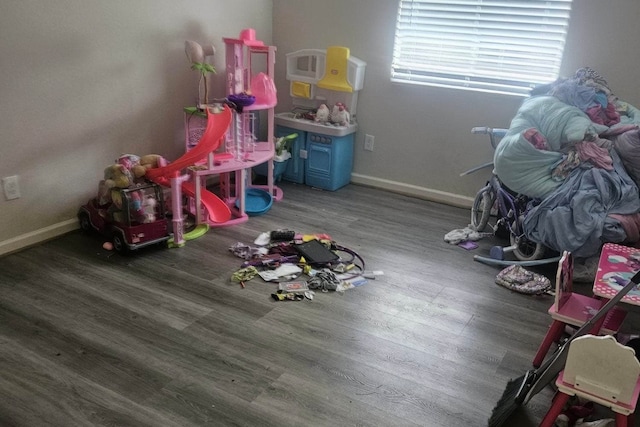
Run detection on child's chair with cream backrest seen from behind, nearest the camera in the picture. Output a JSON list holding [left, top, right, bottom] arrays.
[[540, 335, 640, 427]]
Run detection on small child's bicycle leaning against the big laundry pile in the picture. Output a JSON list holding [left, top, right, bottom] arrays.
[[460, 127, 546, 262]]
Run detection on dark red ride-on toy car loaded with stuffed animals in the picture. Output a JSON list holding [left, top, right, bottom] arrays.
[[78, 184, 171, 252]]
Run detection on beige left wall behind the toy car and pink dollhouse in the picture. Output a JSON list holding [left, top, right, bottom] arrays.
[[0, 0, 272, 254]]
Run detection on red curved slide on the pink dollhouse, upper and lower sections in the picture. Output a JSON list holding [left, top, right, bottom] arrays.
[[145, 105, 232, 223]]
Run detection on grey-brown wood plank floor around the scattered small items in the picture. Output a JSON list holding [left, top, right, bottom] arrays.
[[0, 182, 636, 427]]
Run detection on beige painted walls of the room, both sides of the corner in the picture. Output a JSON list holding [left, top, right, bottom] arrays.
[[0, 0, 640, 255]]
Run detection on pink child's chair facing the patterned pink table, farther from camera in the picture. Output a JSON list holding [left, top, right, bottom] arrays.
[[533, 251, 627, 368]]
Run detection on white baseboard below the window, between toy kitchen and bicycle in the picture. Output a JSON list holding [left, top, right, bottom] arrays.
[[351, 173, 473, 209]]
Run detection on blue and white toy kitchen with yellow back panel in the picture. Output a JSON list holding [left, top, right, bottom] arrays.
[[275, 46, 366, 191]]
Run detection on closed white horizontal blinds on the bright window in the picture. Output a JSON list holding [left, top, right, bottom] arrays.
[[391, 0, 571, 95]]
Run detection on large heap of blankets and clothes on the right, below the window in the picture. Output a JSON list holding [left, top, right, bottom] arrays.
[[494, 68, 640, 258]]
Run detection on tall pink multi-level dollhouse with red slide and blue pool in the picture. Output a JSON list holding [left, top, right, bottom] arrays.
[[146, 29, 282, 245]]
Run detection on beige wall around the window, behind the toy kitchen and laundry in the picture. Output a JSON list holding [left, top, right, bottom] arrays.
[[273, 0, 640, 206]]
